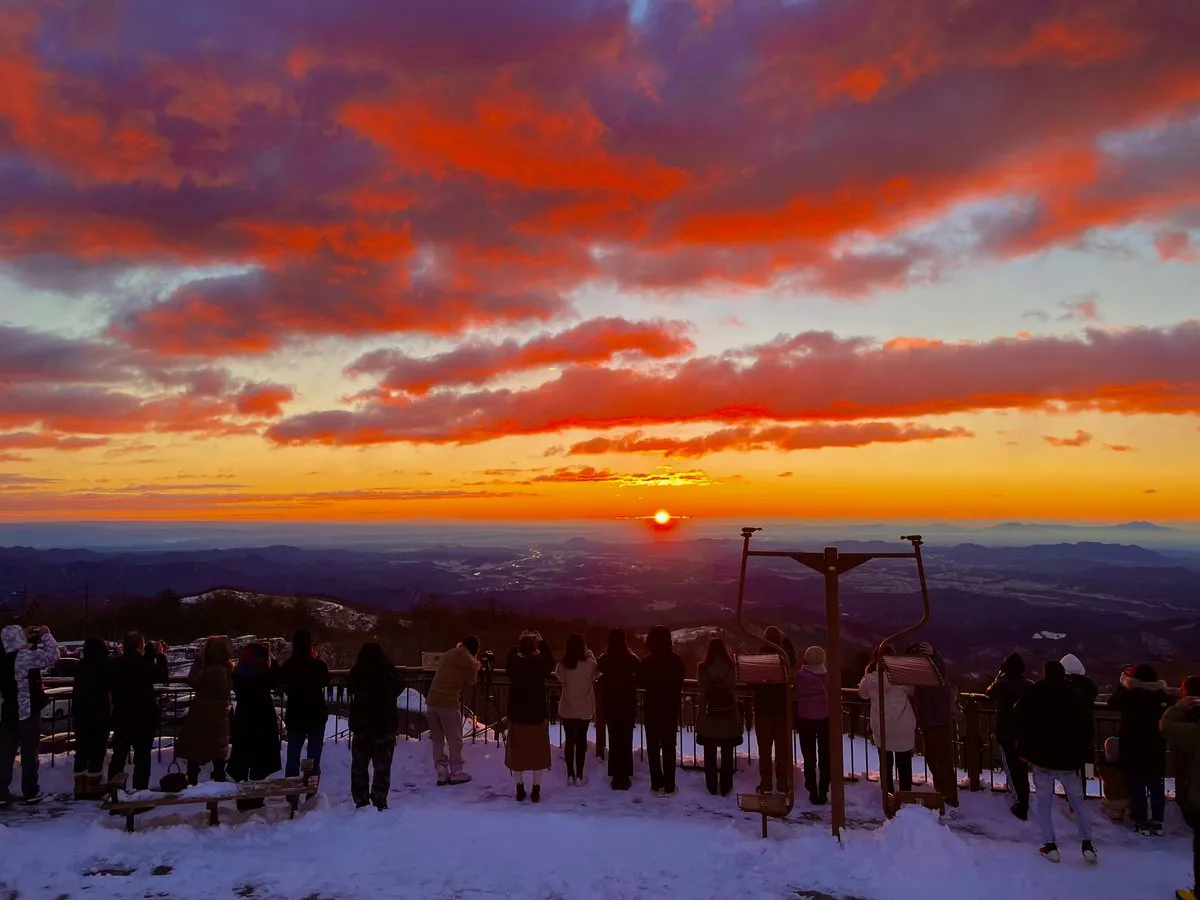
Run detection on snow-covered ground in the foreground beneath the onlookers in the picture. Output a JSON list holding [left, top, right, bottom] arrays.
[[0, 734, 1190, 900]]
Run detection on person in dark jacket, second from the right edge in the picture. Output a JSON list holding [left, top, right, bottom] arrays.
[[1109, 664, 1171, 835]]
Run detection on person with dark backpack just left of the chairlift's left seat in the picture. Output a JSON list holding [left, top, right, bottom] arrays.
[[696, 637, 743, 797]]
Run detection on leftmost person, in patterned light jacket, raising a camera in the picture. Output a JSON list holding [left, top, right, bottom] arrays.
[[0, 625, 59, 806]]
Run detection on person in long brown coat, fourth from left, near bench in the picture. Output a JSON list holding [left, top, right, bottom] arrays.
[[175, 635, 233, 785]]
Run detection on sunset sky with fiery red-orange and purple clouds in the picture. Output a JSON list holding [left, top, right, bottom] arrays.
[[0, 0, 1200, 522]]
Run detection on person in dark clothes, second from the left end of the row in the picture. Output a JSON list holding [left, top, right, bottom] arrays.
[[71, 637, 113, 800]]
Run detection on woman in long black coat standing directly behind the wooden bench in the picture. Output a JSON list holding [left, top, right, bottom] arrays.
[[229, 643, 283, 809]]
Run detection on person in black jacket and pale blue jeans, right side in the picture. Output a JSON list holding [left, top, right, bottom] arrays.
[[1015, 660, 1096, 863]]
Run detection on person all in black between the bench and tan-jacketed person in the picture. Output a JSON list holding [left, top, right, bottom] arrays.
[[346, 641, 404, 812]]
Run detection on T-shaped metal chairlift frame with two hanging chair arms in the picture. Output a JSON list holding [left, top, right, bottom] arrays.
[[738, 527, 941, 840]]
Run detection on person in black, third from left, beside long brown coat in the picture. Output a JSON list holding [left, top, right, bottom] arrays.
[[108, 631, 170, 791]]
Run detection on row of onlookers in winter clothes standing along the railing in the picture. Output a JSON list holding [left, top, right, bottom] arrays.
[[0, 625, 1200, 900]]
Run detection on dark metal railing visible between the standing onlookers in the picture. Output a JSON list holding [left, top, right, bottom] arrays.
[[42, 667, 1137, 797]]
